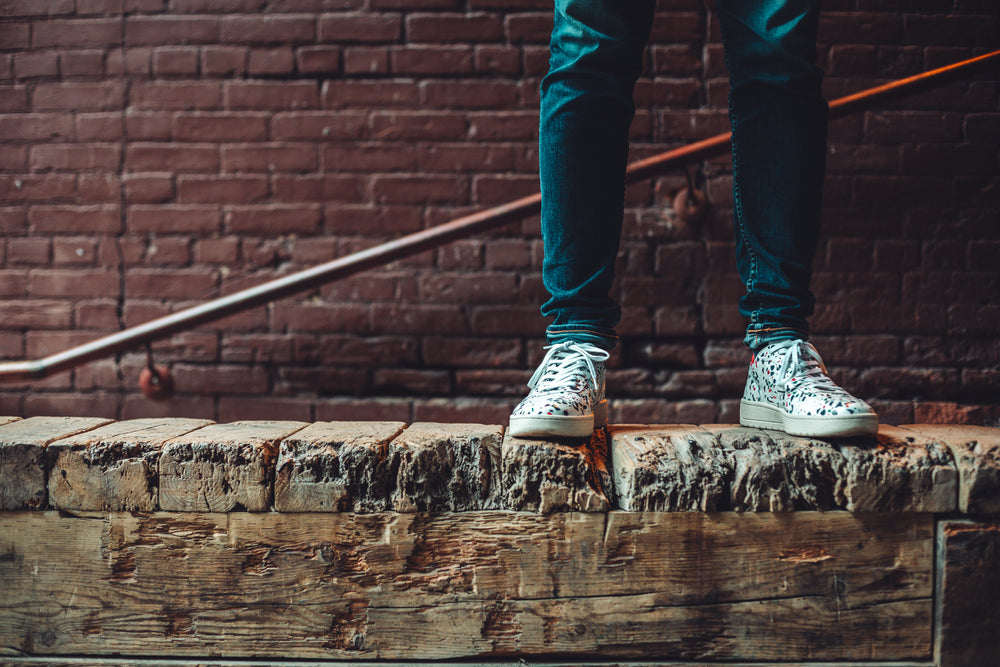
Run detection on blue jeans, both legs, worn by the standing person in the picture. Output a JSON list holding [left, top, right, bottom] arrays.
[[539, 0, 827, 349]]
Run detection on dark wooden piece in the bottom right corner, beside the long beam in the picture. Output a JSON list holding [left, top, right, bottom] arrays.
[[935, 521, 1000, 667]]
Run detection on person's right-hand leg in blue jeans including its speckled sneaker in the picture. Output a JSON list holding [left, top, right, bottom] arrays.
[[718, 0, 878, 436]]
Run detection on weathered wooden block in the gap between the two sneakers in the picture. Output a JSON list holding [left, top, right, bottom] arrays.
[[608, 424, 733, 512]]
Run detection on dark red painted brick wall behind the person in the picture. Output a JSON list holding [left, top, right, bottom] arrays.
[[0, 0, 1000, 424]]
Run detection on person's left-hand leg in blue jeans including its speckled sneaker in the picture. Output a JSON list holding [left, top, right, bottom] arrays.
[[510, 0, 655, 437]]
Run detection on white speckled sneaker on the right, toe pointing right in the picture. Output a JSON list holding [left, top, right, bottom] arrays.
[[740, 340, 878, 437]]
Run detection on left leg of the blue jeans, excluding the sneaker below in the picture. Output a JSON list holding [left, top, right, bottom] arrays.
[[538, 0, 654, 349]]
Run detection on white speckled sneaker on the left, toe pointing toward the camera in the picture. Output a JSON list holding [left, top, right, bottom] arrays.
[[510, 341, 609, 438]]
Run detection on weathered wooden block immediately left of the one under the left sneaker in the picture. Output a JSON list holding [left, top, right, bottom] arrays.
[[386, 422, 503, 512]]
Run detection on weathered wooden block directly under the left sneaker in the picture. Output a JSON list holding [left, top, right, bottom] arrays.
[[501, 429, 615, 513]]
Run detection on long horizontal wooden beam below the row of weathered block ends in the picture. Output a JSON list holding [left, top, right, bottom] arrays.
[[0, 512, 934, 662]]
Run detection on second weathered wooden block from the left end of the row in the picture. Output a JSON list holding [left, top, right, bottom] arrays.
[[48, 419, 212, 512]]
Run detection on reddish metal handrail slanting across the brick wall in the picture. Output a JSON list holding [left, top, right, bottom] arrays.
[[0, 50, 1000, 382]]
